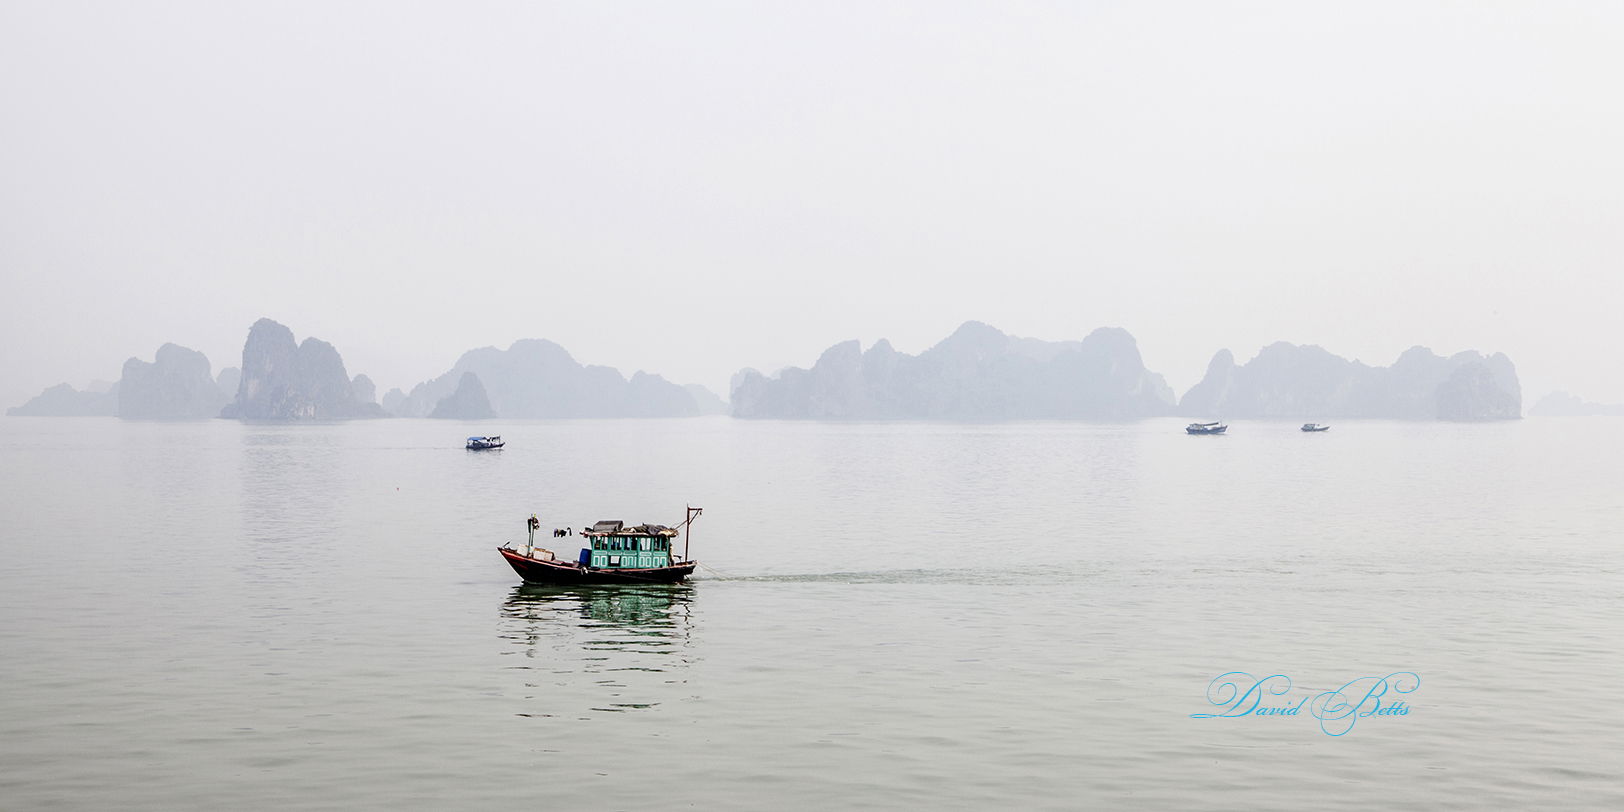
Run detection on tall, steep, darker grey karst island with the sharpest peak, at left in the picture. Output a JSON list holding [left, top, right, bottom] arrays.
[[221, 318, 383, 421]]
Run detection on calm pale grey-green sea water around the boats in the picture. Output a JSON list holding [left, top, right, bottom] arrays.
[[0, 419, 1624, 810]]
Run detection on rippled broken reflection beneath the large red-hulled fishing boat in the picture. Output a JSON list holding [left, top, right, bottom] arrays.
[[500, 583, 693, 716]]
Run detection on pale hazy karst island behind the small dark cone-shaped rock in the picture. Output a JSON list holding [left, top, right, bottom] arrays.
[[385, 338, 717, 417]]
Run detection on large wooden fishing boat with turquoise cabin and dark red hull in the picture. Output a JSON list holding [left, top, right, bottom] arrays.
[[497, 507, 705, 585]]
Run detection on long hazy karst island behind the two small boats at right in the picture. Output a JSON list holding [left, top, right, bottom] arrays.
[[1179, 341, 1522, 421]]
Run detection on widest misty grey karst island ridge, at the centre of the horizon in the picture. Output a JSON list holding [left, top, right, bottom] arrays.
[[731, 322, 1174, 421]]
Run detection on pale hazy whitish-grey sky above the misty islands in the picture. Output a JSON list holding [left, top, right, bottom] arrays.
[[0, 0, 1624, 406]]
